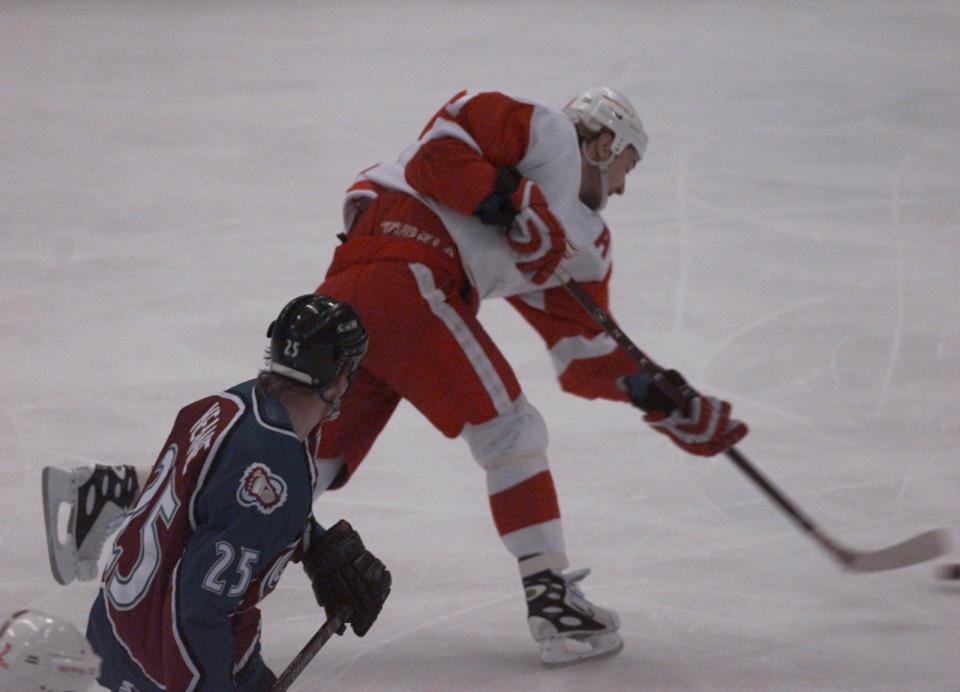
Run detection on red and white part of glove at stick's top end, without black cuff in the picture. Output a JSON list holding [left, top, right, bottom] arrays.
[[507, 178, 567, 284]]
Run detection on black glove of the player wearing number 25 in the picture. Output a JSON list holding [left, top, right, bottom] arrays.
[[303, 519, 392, 637]]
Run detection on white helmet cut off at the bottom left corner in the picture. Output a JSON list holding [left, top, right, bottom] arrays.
[[0, 610, 100, 692]]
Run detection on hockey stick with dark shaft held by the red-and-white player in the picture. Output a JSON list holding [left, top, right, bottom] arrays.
[[553, 266, 949, 572]]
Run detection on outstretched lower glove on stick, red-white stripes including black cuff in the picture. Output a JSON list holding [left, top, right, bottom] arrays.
[[623, 370, 749, 457]]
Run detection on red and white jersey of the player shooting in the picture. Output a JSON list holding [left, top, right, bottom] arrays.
[[338, 92, 637, 401]]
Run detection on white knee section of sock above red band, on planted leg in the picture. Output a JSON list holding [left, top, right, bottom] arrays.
[[460, 394, 548, 468]]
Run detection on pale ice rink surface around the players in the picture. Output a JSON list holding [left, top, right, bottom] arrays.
[[0, 0, 960, 692]]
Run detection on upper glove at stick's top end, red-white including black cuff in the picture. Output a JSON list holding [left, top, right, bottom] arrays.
[[474, 166, 567, 284]]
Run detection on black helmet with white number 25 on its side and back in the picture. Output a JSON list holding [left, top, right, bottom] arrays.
[[267, 293, 367, 389]]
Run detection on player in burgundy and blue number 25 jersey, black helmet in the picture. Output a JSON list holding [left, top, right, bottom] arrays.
[[44, 295, 390, 692]]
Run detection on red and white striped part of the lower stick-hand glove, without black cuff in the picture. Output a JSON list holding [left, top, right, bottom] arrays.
[[643, 395, 749, 457]]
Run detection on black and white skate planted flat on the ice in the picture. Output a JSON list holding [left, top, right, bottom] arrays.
[[523, 569, 623, 668]]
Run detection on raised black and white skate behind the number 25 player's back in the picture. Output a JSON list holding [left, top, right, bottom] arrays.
[[42, 464, 139, 584]]
